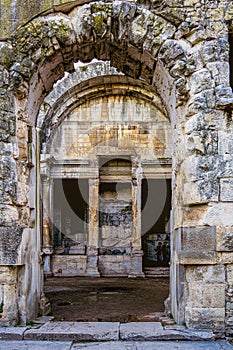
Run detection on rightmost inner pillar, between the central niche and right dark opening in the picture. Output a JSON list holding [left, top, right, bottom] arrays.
[[128, 163, 145, 277]]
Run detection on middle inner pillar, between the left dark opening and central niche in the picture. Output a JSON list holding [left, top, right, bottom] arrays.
[[87, 179, 100, 277]]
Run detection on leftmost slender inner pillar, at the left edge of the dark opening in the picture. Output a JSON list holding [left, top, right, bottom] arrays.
[[42, 177, 53, 276]]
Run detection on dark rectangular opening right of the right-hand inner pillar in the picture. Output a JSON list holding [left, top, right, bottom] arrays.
[[142, 179, 171, 276]]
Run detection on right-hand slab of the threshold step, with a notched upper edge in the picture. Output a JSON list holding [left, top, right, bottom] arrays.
[[120, 322, 215, 341]]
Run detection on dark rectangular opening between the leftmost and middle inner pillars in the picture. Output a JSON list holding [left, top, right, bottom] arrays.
[[53, 179, 89, 255]]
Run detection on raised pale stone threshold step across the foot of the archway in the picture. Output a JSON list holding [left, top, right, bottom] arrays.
[[0, 321, 215, 342]]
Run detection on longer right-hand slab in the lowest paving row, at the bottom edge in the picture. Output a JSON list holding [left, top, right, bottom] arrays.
[[72, 341, 233, 350]]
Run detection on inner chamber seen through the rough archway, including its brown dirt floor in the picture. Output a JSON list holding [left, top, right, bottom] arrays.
[[38, 64, 172, 322]]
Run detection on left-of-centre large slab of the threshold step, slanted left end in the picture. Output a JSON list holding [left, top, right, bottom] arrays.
[[24, 322, 119, 341]]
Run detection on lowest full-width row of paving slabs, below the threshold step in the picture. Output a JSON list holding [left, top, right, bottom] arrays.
[[0, 340, 233, 350]]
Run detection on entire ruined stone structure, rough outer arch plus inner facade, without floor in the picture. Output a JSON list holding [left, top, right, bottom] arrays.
[[0, 0, 233, 335]]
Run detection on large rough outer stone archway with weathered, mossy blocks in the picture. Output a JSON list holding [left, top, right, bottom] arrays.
[[1, 2, 233, 331]]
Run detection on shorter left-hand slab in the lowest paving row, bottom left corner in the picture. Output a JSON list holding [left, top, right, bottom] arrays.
[[0, 340, 72, 350]]
